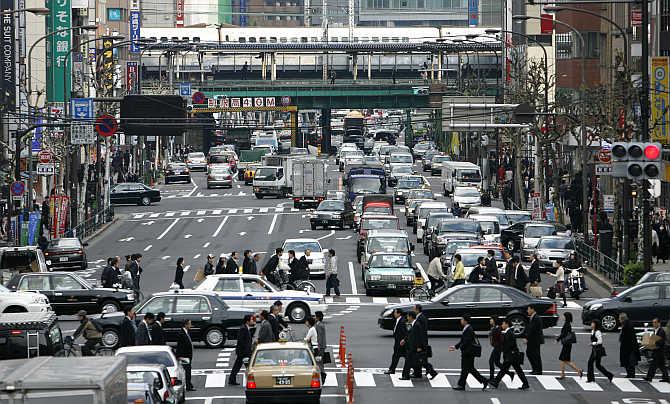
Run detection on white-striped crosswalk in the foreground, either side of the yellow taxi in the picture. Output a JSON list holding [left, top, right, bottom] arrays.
[[193, 365, 670, 394]]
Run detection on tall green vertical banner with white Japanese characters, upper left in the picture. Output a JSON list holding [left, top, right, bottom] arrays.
[[46, 0, 72, 102]]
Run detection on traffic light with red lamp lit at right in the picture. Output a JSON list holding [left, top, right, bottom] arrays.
[[612, 142, 663, 180]]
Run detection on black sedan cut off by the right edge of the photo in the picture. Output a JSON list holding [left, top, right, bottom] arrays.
[[582, 282, 670, 331]]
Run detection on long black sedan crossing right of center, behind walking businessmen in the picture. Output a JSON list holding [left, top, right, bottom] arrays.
[[378, 284, 558, 336]]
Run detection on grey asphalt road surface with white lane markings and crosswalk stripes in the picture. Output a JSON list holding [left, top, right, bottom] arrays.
[[64, 157, 670, 404]]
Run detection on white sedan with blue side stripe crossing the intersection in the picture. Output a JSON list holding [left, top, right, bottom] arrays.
[[196, 274, 326, 322]]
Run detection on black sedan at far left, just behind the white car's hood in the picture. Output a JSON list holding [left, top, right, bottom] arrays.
[[6, 272, 135, 315]]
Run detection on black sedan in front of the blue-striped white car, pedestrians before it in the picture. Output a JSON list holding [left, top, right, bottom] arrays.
[[97, 290, 254, 348]]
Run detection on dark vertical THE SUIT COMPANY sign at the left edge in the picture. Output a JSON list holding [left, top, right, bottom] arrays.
[[0, 0, 17, 111]]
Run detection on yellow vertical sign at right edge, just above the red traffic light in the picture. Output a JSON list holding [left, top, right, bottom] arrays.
[[650, 56, 670, 145]]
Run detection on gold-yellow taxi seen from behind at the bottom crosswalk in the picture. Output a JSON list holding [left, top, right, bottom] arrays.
[[245, 342, 321, 404]]
